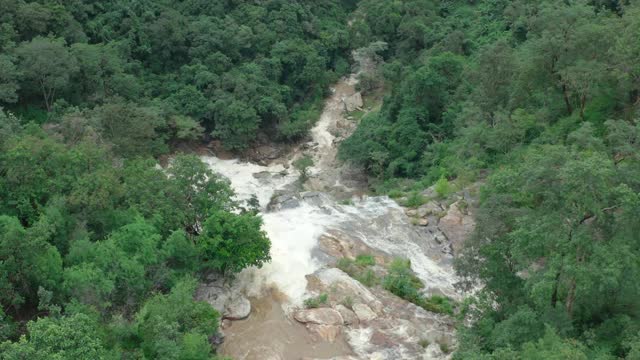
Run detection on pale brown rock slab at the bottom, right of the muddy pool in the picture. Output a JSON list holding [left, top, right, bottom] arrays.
[[296, 268, 455, 360]]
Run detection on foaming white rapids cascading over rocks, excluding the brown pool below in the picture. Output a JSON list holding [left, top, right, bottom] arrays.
[[202, 78, 455, 307]]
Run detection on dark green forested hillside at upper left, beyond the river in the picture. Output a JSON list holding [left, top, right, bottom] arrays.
[[0, 0, 352, 150]]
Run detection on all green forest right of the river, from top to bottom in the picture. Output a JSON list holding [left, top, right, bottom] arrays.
[[340, 0, 640, 359]]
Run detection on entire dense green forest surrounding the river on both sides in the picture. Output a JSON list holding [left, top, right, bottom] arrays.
[[0, 0, 640, 360]]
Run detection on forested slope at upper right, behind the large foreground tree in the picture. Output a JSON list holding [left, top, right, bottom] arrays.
[[341, 0, 640, 183]]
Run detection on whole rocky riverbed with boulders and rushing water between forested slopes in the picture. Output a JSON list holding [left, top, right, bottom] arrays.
[[196, 76, 474, 359]]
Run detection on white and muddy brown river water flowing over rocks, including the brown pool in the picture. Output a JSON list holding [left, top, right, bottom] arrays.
[[203, 77, 456, 359]]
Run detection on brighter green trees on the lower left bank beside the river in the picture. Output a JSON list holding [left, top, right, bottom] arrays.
[[0, 119, 270, 359]]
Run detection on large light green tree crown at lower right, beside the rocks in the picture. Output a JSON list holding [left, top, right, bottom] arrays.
[[457, 143, 640, 349]]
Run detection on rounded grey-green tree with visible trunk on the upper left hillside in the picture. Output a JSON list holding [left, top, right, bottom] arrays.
[[15, 37, 78, 111]]
